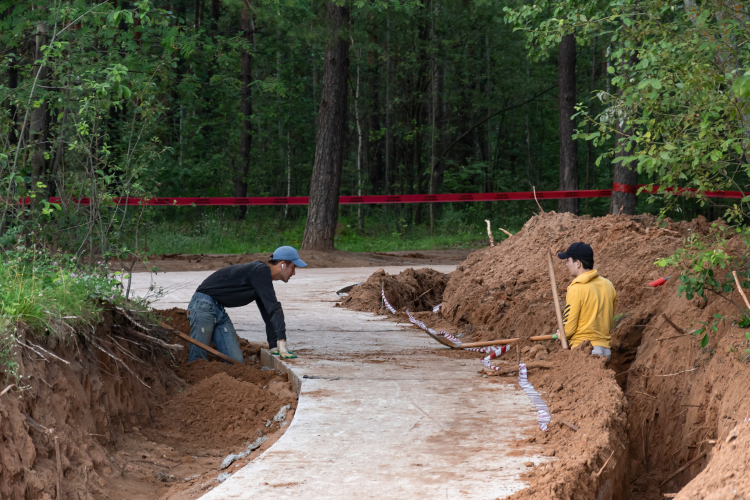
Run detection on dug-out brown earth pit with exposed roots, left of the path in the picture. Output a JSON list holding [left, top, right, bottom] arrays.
[[0, 309, 297, 500]]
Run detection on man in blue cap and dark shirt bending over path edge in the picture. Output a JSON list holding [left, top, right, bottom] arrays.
[[187, 246, 307, 363]]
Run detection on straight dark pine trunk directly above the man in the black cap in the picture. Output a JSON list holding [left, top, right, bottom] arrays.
[[557, 35, 578, 214]]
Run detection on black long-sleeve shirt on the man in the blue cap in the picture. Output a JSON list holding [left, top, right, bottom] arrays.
[[196, 261, 286, 340]]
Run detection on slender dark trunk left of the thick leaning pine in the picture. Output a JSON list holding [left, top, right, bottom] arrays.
[[234, 7, 254, 219]]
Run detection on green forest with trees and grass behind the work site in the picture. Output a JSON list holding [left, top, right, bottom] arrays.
[[0, 0, 750, 263]]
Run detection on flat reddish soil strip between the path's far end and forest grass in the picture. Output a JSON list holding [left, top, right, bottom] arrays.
[[122, 248, 472, 272]]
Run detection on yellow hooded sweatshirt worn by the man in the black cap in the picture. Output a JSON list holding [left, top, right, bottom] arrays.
[[563, 269, 617, 349]]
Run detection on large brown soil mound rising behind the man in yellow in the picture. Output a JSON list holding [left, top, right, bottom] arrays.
[[442, 209, 708, 338]]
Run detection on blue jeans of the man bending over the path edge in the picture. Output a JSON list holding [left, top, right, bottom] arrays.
[[187, 292, 242, 363]]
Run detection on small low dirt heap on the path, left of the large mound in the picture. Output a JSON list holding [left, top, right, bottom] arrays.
[[342, 268, 450, 312]]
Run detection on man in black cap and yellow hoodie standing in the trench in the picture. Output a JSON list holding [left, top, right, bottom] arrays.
[[557, 242, 617, 359]]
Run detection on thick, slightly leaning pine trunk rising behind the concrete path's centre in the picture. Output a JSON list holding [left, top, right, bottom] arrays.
[[301, 0, 349, 251]]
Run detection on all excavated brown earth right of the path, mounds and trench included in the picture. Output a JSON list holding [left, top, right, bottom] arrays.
[[343, 212, 750, 500]]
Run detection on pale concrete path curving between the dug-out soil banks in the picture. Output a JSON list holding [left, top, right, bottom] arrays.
[[134, 266, 544, 500]]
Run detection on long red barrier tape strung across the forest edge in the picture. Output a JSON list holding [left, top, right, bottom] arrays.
[[5, 183, 743, 207]]
